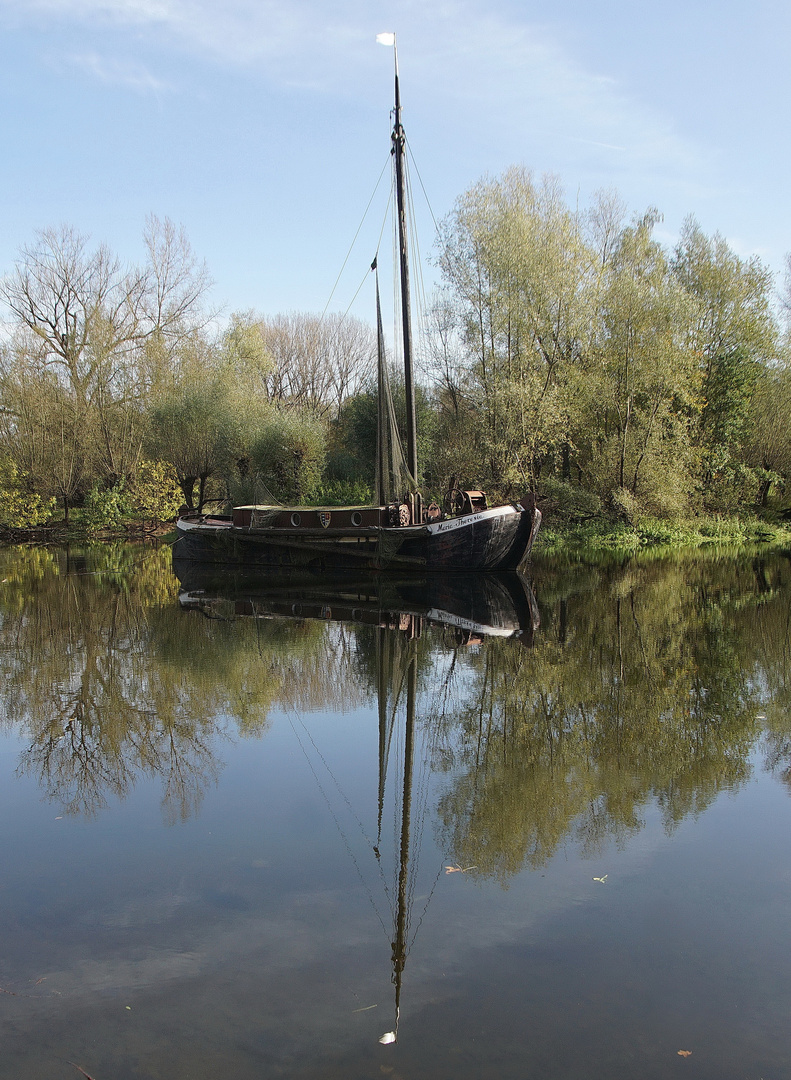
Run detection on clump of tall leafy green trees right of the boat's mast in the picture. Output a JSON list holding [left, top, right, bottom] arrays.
[[434, 176, 777, 519]]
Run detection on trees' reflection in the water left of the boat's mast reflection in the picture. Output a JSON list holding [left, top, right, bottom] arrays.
[[0, 545, 343, 821]]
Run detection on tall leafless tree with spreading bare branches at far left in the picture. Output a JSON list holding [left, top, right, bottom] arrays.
[[0, 216, 210, 490]]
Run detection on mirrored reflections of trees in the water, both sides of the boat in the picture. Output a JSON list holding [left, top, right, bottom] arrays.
[[0, 545, 791, 885]]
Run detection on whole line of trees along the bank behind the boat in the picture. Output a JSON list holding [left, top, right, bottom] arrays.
[[0, 168, 791, 527]]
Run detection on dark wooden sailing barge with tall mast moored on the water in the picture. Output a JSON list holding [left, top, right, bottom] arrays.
[[176, 42, 541, 571]]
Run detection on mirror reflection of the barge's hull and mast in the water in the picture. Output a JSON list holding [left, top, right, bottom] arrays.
[[174, 553, 539, 1044]]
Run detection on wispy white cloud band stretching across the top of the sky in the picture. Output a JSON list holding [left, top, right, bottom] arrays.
[[0, 0, 706, 175]]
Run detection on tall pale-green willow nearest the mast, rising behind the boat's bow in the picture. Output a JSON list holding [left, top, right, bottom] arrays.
[[439, 168, 599, 489]]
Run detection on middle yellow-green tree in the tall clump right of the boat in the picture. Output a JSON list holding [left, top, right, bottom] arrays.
[[578, 212, 699, 513]]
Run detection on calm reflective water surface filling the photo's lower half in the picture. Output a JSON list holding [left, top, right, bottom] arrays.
[[0, 548, 791, 1080]]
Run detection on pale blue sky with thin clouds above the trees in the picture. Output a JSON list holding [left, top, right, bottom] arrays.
[[0, 0, 791, 313]]
